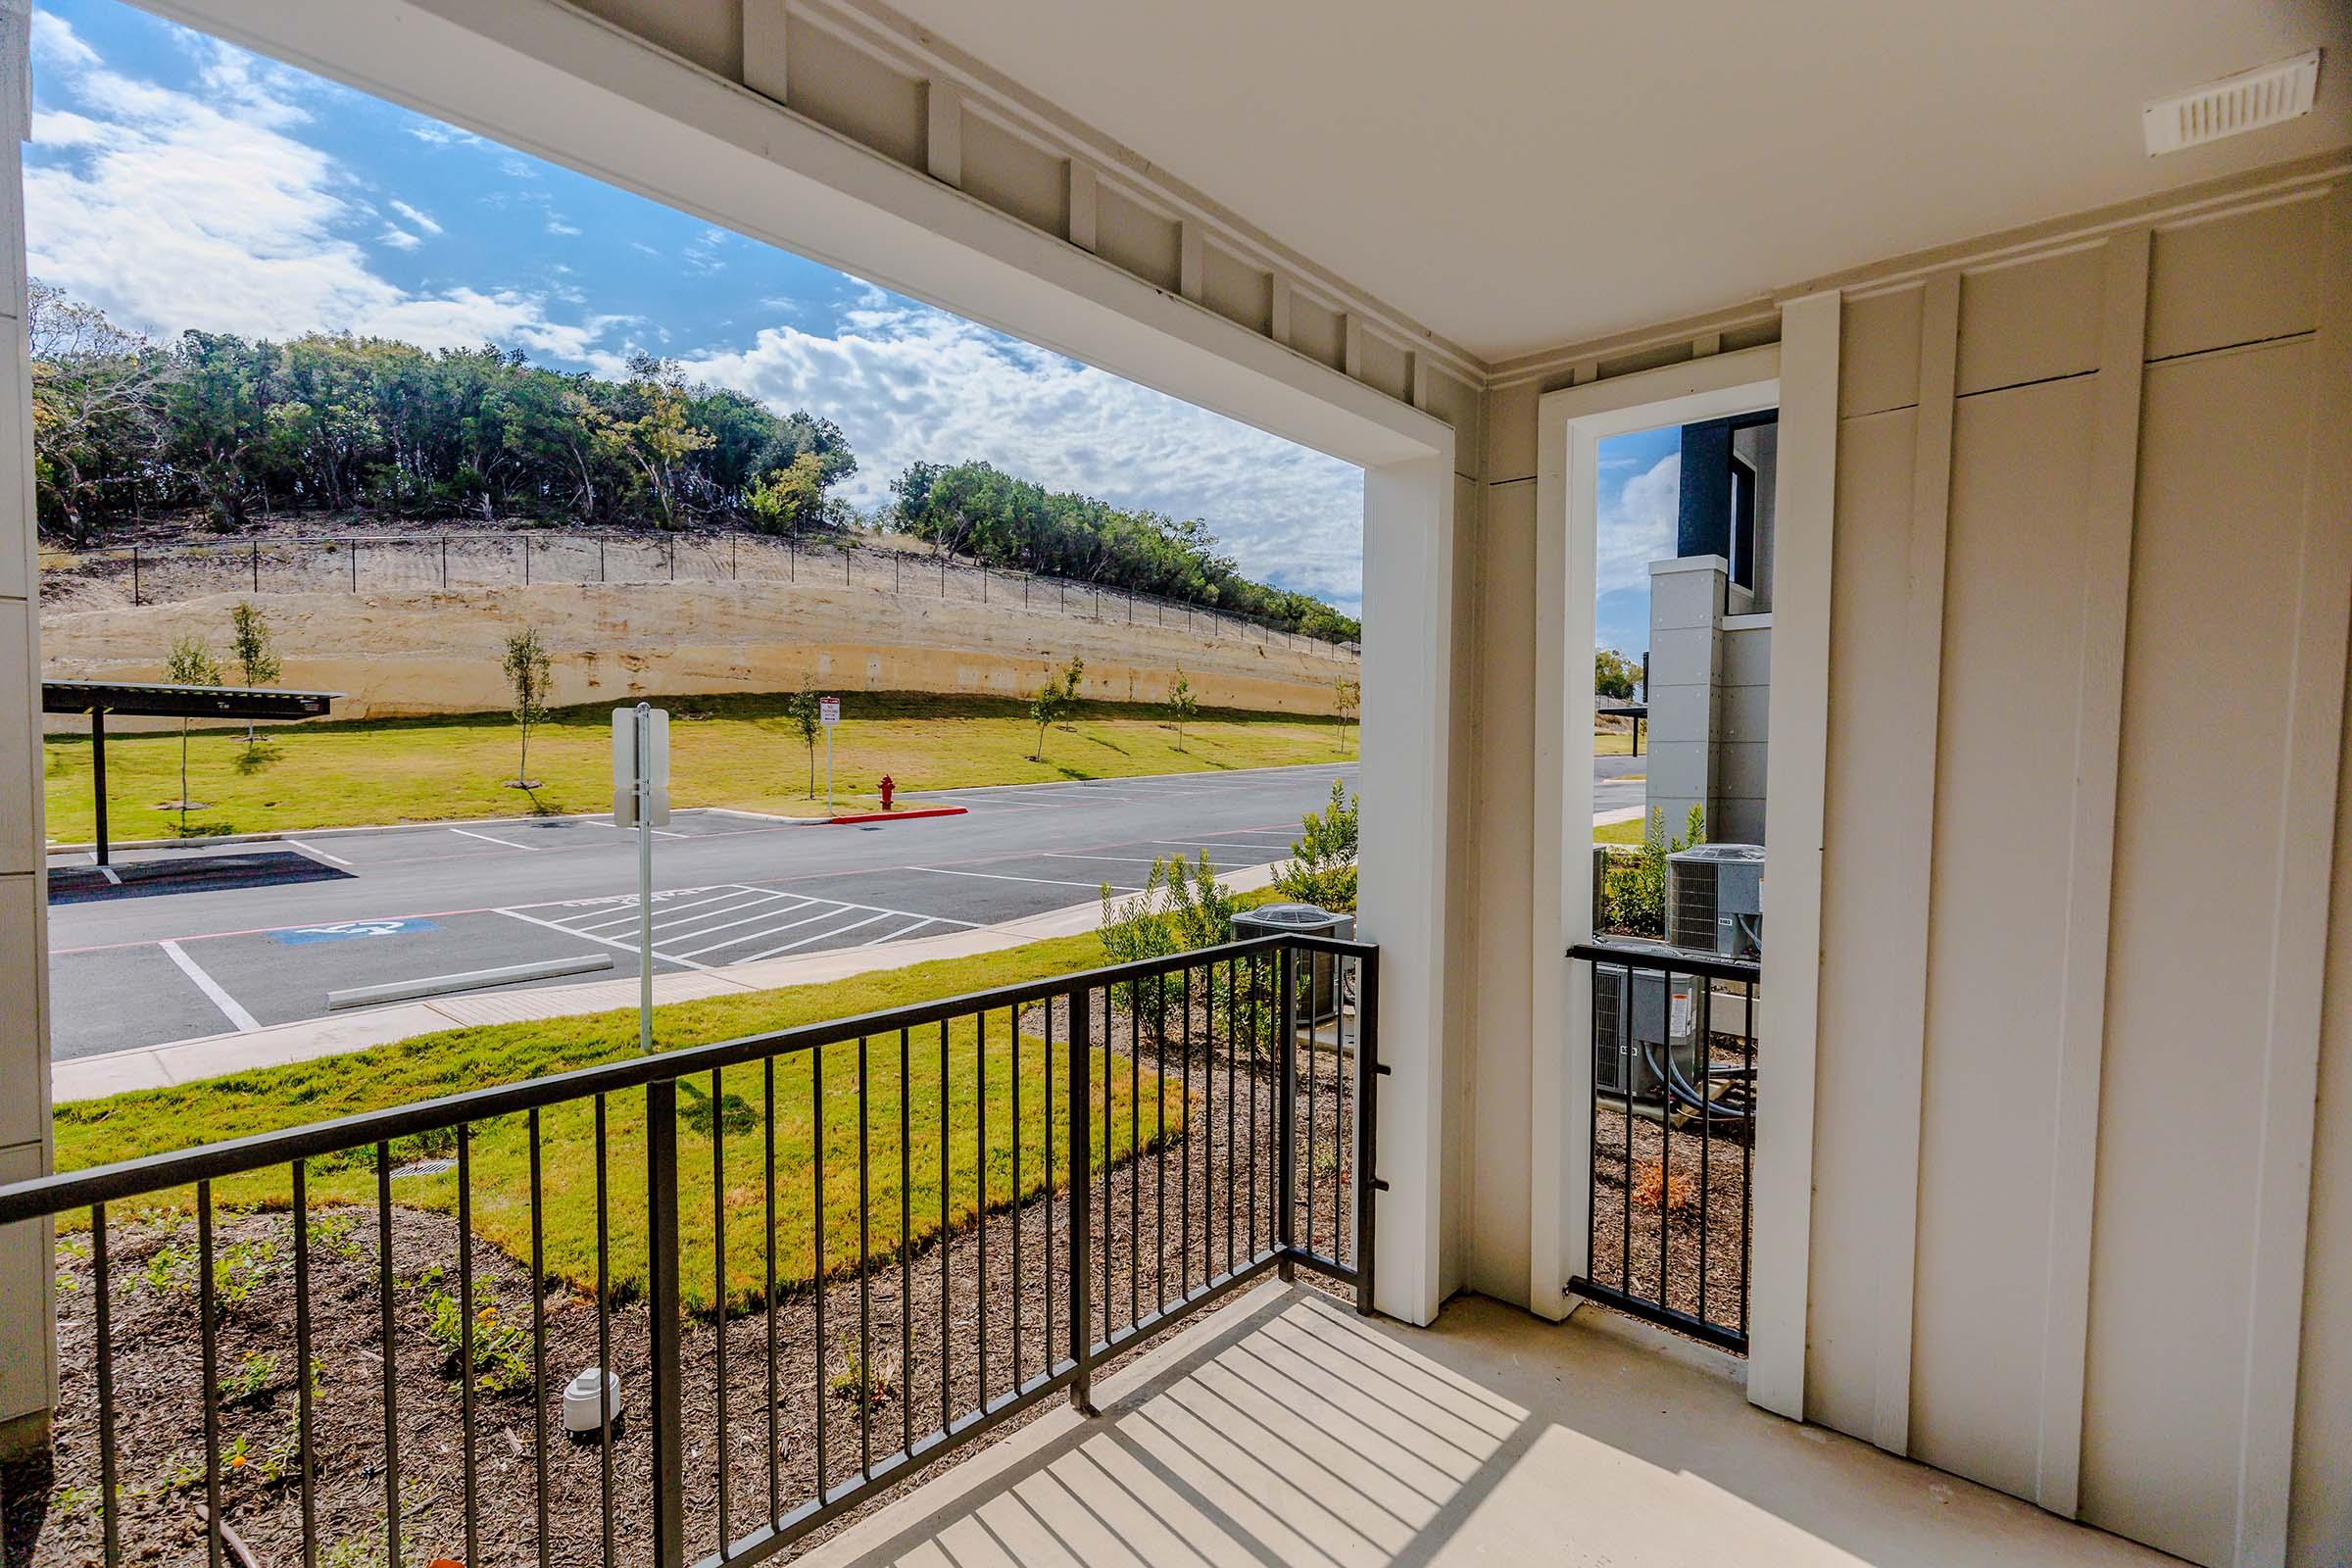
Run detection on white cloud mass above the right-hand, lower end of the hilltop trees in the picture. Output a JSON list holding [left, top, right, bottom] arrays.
[[684, 291, 1364, 609]]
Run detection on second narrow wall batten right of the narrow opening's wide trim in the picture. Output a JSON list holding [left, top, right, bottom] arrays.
[[2034, 228, 2150, 1519]]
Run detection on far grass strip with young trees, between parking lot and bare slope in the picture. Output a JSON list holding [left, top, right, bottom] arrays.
[[42, 691, 1354, 844]]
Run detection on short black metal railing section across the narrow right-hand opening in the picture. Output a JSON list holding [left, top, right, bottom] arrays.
[[1569, 941, 1759, 1351]]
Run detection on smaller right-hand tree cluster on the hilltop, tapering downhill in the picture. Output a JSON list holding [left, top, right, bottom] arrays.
[[892, 464, 1364, 642]]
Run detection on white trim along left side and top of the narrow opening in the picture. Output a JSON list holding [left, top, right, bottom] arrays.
[[1527, 346, 1768, 1319]]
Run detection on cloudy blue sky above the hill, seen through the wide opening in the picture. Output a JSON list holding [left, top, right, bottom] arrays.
[[24, 0, 1364, 613]]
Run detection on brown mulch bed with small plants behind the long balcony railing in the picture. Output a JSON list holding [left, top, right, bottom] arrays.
[[0, 1039, 1352, 1568]]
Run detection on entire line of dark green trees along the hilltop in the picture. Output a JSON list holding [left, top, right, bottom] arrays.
[[25, 279, 1362, 642]]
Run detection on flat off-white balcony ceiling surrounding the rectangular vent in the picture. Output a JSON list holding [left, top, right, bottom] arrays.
[[894, 0, 2352, 360]]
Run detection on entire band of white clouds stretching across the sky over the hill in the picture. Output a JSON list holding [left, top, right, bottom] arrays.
[[25, 12, 1373, 609]]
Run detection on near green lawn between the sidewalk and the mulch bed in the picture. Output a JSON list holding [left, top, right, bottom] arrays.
[[54, 936, 1186, 1314]]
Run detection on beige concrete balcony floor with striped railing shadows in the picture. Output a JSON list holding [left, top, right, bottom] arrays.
[[807, 1284, 2176, 1568]]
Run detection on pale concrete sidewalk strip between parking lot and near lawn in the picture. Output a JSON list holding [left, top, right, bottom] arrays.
[[49, 862, 1280, 1104]]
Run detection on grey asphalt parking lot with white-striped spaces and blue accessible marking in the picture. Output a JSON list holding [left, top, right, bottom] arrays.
[[49, 757, 1642, 1057]]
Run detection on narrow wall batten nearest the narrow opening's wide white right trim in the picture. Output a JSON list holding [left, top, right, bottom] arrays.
[[1872, 272, 1959, 1452]]
